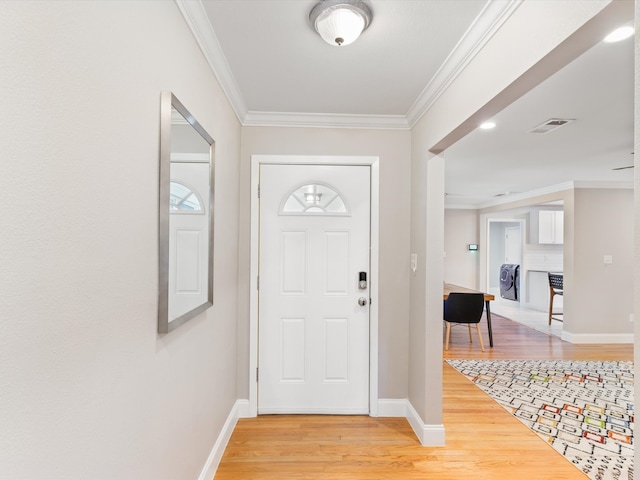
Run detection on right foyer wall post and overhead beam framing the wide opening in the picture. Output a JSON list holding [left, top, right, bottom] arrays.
[[409, 0, 628, 438]]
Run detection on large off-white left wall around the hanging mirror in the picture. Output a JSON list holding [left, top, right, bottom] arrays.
[[0, 1, 240, 480]]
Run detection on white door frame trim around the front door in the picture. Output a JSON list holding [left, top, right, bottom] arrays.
[[247, 155, 380, 417]]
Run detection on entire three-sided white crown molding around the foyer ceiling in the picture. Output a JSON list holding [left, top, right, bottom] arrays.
[[174, 0, 523, 130]]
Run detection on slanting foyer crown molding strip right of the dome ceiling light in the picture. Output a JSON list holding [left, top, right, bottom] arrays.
[[406, 0, 523, 128]]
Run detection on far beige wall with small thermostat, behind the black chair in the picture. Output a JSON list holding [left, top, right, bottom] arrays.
[[444, 209, 483, 288]]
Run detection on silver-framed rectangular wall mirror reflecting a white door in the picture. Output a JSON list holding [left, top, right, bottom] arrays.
[[158, 92, 215, 333]]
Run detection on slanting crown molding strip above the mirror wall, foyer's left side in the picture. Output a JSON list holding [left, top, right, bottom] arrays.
[[174, 0, 247, 123]]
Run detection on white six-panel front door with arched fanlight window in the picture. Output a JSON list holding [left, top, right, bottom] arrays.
[[258, 165, 371, 414]]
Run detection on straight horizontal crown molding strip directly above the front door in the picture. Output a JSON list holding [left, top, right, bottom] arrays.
[[243, 112, 410, 130]]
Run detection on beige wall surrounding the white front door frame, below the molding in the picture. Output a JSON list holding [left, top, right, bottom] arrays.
[[238, 127, 411, 399]]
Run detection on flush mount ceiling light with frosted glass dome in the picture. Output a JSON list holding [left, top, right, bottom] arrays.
[[309, 0, 373, 47]]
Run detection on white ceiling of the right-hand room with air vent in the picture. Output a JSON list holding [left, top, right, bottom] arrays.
[[445, 22, 634, 206]]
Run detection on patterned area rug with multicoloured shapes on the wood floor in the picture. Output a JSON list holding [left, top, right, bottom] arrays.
[[447, 360, 634, 480]]
